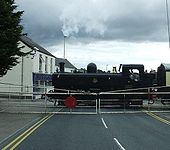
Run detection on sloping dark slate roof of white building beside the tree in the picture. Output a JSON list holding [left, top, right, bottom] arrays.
[[20, 36, 55, 57]]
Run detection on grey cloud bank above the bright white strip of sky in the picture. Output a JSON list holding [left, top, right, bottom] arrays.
[[16, 0, 167, 45]]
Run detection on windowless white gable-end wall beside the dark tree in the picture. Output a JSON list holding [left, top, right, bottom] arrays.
[[0, 42, 33, 92]]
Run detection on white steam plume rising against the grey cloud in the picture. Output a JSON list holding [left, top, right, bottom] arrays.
[[60, 0, 109, 36]]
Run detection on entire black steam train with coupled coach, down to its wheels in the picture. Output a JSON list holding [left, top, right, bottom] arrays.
[[47, 63, 170, 108]]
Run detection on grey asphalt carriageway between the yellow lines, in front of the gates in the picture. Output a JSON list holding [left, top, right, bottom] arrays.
[[0, 113, 170, 150]]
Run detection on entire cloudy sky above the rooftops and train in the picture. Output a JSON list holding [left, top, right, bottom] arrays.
[[16, 0, 170, 70]]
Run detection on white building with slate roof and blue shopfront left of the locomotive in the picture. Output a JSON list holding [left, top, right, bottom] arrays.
[[0, 36, 73, 96]]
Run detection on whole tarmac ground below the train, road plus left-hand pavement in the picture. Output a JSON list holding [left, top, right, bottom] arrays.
[[0, 98, 170, 150]]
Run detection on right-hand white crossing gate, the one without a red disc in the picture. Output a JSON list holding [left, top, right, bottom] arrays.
[[99, 86, 170, 113]]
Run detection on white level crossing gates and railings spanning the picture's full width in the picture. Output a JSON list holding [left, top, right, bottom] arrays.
[[0, 85, 170, 114]]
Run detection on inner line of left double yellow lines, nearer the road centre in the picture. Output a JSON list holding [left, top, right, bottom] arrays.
[[10, 114, 54, 150]]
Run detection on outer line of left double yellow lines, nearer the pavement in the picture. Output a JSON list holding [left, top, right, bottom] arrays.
[[2, 115, 49, 150]]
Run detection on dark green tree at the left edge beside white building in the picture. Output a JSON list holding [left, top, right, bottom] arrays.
[[0, 0, 24, 77]]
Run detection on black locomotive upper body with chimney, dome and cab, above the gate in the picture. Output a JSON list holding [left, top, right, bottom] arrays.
[[52, 63, 157, 93]]
